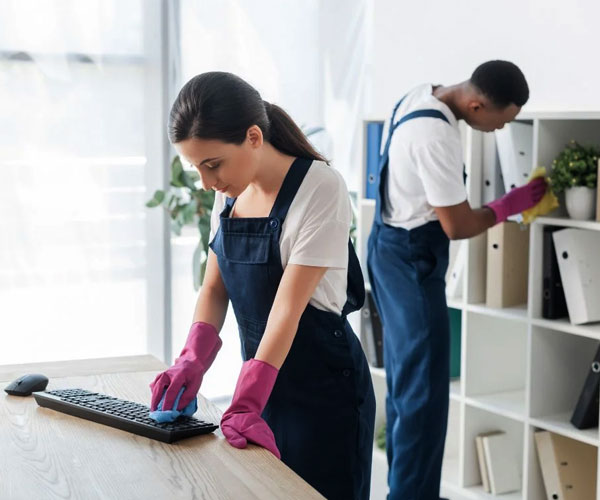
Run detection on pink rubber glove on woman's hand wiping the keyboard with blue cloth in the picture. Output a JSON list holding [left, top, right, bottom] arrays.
[[150, 321, 223, 411]]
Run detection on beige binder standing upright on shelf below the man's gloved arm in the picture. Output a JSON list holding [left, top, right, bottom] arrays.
[[486, 222, 529, 308]]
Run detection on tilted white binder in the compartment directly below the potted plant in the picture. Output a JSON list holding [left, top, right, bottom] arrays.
[[553, 229, 600, 325]]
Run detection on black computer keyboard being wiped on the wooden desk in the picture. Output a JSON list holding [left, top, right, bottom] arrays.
[[33, 389, 218, 443]]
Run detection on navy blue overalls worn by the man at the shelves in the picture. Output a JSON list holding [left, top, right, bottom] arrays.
[[367, 98, 450, 500]]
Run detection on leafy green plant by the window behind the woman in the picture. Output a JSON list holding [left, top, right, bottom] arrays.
[[146, 156, 215, 291]]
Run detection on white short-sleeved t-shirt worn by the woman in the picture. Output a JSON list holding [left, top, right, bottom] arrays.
[[210, 161, 352, 314]]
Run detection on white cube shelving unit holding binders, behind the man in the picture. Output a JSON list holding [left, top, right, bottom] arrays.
[[357, 112, 600, 500]]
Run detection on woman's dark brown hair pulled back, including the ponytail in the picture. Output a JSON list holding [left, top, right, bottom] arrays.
[[168, 71, 326, 161]]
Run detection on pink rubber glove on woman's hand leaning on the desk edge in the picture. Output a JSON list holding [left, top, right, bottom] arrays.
[[221, 359, 281, 459]]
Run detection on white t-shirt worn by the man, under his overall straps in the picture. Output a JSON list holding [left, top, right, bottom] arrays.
[[381, 84, 467, 229]]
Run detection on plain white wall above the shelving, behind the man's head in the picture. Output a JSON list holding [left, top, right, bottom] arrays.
[[367, 0, 600, 116]]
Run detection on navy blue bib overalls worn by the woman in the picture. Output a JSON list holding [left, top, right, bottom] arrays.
[[210, 158, 375, 500]]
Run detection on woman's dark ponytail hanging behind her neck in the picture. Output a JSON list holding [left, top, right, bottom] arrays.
[[263, 101, 327, 161]]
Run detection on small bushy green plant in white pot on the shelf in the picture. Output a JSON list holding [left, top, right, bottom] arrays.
[[550, 140, 600, 220]]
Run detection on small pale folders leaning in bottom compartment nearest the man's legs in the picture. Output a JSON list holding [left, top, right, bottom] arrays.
[[475, 431, 521, 495]]
